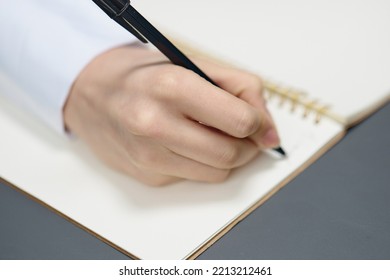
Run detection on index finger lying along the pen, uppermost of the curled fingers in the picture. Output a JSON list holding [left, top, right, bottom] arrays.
[[153, 69, 261, 138]]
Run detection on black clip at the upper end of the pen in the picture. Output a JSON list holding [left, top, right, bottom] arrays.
[[93, 0, 148, 44]]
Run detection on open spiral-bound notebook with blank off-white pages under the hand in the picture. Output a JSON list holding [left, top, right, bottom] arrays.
[[0, 0, 390, 259]]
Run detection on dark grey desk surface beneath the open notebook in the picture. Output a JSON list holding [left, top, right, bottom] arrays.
[[0, 104, 390, 259]]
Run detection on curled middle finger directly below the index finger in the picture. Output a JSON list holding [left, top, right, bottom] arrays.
[[121, 105, 259, 169]]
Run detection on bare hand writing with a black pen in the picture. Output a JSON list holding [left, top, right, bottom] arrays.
[[64, 46, 279, 185]]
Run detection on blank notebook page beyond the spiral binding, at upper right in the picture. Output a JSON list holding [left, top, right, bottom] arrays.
[[136, 0, 390, 123]]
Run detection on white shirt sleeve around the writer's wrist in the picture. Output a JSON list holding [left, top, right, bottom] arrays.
[[0, 0, 136, 133]]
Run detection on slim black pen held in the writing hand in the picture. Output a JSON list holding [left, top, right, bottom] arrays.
[[93, 0, 286, 156]]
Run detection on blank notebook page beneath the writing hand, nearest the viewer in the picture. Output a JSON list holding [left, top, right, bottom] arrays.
[[0, 76, 343, 259]]
